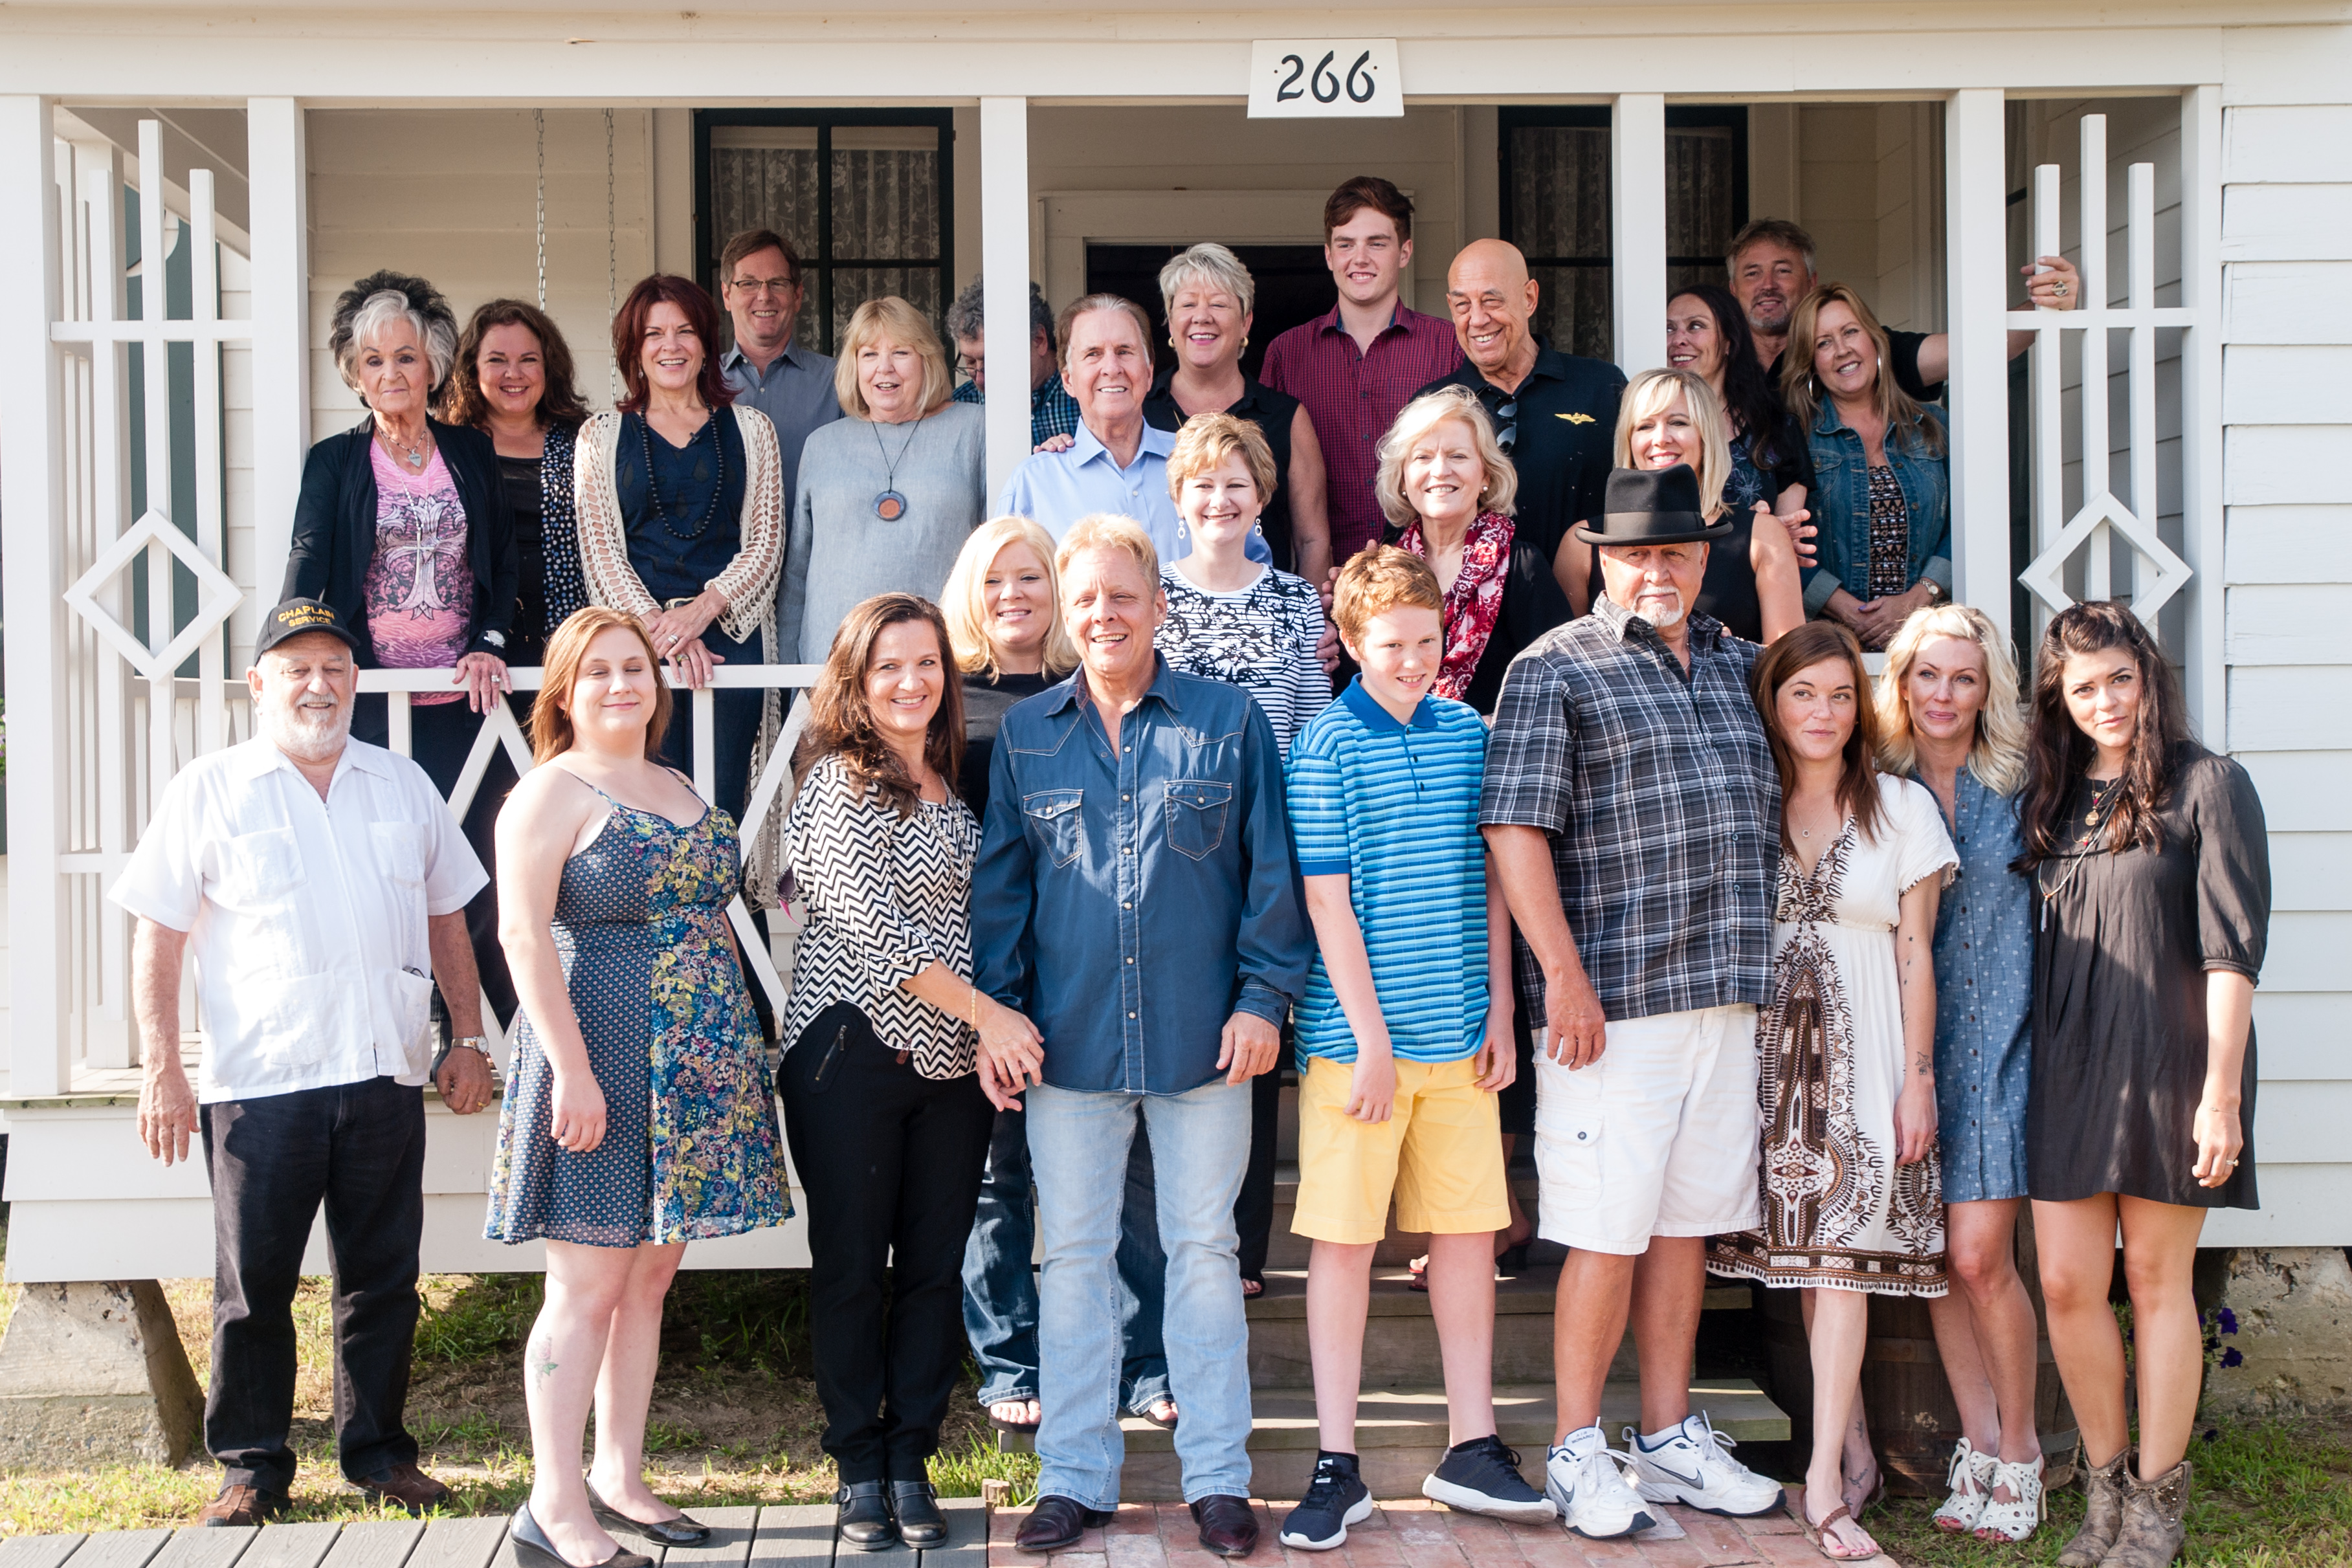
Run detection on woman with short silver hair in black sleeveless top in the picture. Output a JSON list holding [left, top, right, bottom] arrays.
[[1143, 245, 1336, 583]]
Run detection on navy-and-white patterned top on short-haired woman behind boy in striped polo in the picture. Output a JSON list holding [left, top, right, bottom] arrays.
[[1153, 566, 1331, 757]]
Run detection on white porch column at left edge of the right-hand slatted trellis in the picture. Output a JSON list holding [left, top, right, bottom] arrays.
[[1943, 87, 2039, 632]]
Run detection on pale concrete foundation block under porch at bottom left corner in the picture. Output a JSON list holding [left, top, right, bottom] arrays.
[[0, 1279, 205, 1469]]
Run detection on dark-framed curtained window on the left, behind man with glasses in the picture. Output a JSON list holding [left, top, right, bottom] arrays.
[[696, 108, 955, 353]]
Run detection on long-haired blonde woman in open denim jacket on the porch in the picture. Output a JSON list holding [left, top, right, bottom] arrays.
[[1781, 282, 1952, 649]]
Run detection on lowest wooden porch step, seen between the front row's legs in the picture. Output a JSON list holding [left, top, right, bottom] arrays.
[[999, 1378, 1788, 1502]]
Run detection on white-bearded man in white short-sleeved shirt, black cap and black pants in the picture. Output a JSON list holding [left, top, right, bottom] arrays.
[[108, 599, 492, 1526]]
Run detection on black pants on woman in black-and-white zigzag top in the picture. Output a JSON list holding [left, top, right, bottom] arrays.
[[779, 1041, 995, 1486]]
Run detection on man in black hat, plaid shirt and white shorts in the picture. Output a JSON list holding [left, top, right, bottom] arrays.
[[1480, 463, 1781, 1538]]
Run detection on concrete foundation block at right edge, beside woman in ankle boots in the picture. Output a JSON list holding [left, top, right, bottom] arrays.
[[2206, 1246, 2352, 1415]]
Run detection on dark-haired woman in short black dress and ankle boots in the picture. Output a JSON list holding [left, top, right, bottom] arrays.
[[2018, 604, 2270, 1568]]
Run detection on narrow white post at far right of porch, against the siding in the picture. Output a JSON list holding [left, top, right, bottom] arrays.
[[2149, 87, 2230, 752]]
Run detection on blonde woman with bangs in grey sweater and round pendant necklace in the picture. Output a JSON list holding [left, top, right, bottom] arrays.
[[776, 294, 988, 665]]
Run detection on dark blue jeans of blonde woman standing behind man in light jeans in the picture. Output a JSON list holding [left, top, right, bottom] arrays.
[[964, 1110, 1169, 1413]]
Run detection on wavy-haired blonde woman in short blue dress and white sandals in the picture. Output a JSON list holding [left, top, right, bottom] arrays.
[[1877, 604, 2041, 1540]]
